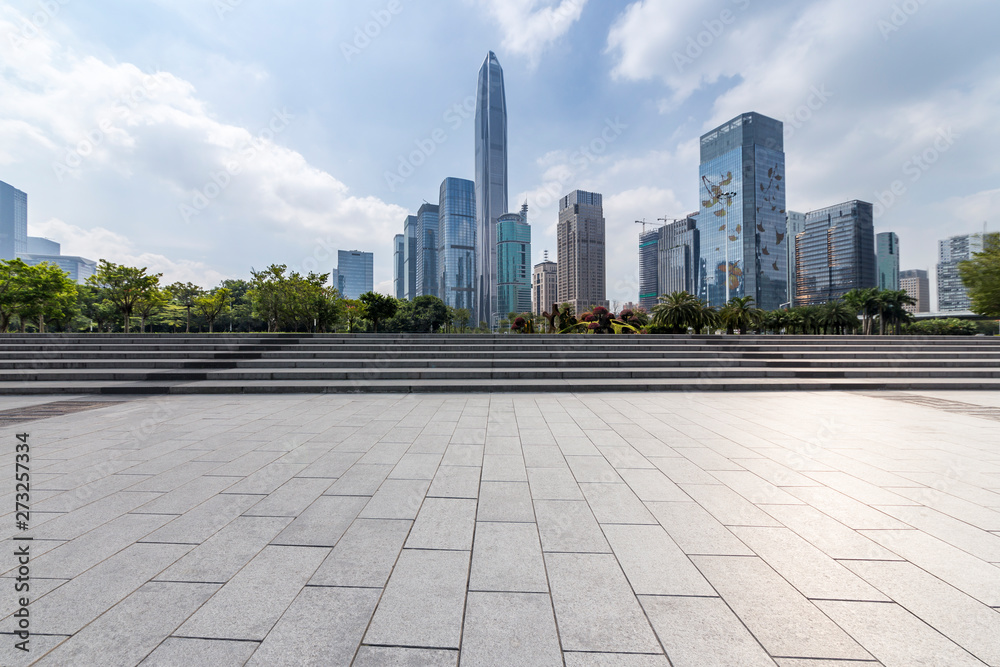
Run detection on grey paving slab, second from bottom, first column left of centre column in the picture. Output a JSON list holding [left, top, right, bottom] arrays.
[[364, 549, 470, 649]]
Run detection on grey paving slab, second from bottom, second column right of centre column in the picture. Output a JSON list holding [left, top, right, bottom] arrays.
[[604, 525, 716, 596]]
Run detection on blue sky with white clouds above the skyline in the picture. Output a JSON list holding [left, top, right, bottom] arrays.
[[0, 0, 1000, 302]]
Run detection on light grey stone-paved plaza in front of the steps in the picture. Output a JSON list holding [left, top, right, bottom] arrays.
[[0, 391, 1000, 667]]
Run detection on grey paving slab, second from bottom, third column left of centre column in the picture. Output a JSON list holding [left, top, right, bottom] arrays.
[[174, 546, 330, 641]]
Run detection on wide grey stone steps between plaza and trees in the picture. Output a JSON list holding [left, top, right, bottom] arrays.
[[0, 334, 1000, 394]]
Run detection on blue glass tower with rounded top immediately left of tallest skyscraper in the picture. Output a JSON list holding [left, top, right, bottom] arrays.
[[437, 178, 478, 314]]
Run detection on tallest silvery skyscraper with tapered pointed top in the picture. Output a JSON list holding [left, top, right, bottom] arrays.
[[473, 51, 507, 329]]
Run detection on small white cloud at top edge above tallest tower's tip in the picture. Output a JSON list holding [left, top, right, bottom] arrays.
[[482, 0, 587, 66]]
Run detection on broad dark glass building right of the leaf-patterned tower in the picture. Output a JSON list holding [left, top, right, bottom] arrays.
[[795, 200, 878, 306]]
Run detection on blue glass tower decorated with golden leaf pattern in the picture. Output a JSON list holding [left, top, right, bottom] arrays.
[[698, 113, 788, 310]]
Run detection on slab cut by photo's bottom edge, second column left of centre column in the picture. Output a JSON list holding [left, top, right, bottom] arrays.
[[247, 586, 380, 667]]
